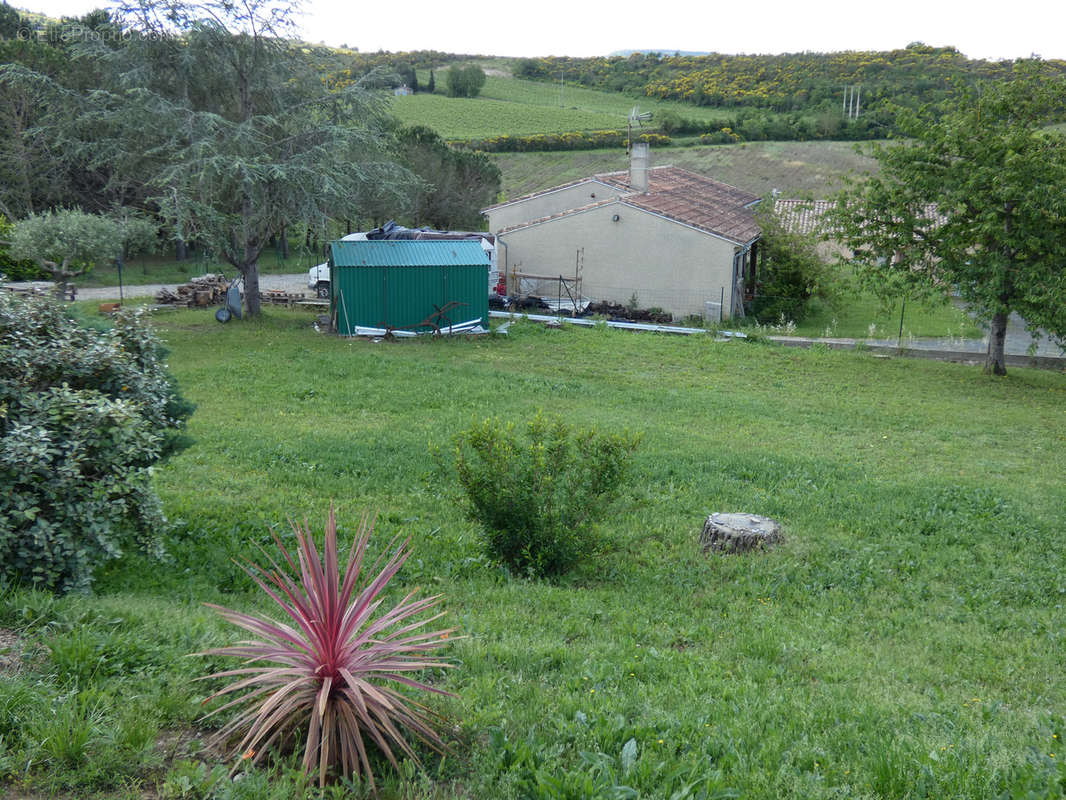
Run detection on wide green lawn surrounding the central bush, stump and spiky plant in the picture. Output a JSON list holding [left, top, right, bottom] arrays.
[[0, 310, 1066, 800]]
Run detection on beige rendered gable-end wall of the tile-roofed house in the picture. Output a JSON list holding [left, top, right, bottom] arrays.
[[500, 202, 739, 318]]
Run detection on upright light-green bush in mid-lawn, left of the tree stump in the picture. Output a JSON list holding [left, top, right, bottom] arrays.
[[445, 414, 640, 576]]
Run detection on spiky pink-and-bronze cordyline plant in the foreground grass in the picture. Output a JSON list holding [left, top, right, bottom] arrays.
[[198, 507, 454, 793]]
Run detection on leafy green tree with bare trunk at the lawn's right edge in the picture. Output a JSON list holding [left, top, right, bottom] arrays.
[[833, 62, 1066, 374]]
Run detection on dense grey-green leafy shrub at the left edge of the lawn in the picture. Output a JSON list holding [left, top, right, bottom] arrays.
[[0, 294, 192, 591]]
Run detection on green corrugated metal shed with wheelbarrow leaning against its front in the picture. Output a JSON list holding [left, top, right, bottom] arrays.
[[329, 240, 489, 336]]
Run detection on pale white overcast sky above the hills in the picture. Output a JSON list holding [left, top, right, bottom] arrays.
[[9, 0, 1066, 59]]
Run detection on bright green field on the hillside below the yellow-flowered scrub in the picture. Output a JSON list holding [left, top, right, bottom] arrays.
[[392, 70, 727, 139]]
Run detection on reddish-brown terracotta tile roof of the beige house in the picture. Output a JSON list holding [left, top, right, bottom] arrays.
[[485, 166, 761, 244]]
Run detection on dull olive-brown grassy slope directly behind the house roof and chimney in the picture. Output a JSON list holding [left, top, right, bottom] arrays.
[[492, 142, 875, 199]]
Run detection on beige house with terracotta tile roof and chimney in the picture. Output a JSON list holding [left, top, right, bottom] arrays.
[[484, 144, 760, 319]]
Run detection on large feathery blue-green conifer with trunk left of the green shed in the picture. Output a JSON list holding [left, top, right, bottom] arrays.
[[19, 0, 410, 315]]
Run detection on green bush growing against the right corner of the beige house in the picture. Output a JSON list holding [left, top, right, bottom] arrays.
[[745, 212, 840, 324]]
